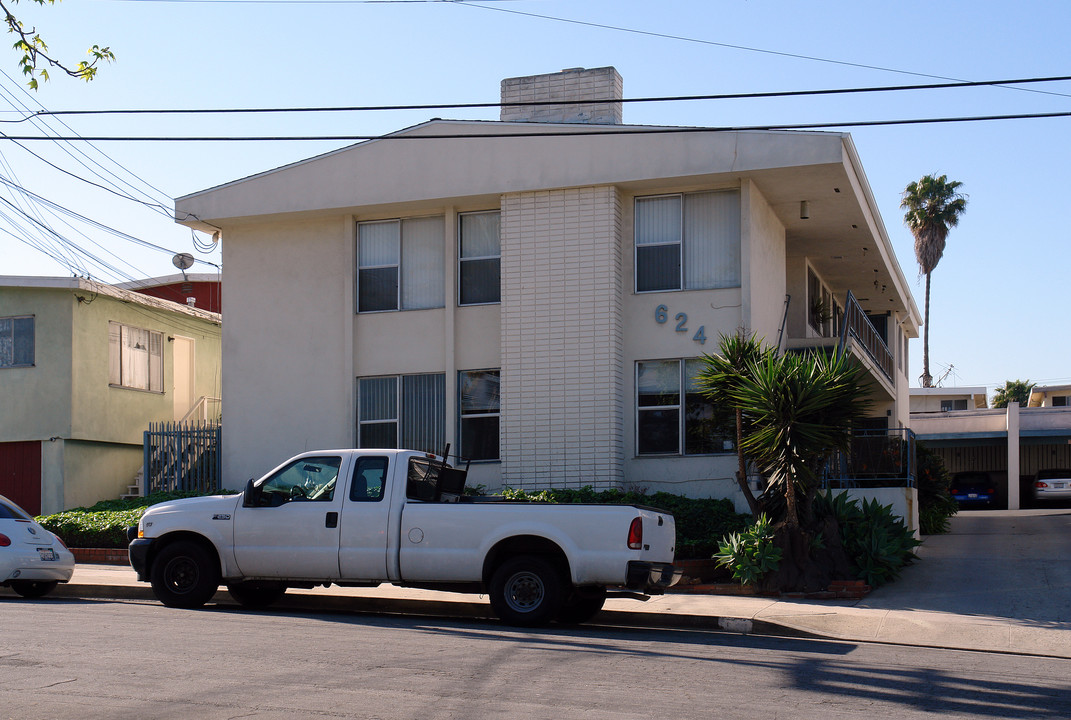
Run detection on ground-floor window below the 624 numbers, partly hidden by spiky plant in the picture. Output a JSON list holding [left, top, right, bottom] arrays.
[[636, 358, 735, 455]]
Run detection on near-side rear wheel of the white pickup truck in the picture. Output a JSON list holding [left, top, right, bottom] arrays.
[[491, 555, 563, 628]]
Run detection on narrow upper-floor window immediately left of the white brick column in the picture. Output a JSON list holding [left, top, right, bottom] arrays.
[[457, 210, 501, 305]]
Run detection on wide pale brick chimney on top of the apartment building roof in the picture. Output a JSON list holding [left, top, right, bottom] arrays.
[[500, 68, 623, 125]]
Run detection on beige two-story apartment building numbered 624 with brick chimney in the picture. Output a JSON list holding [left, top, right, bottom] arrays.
[[176, 68, 919, 505]]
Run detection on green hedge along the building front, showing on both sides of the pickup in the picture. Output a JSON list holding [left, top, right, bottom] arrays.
[[37, 488, 751, 558]]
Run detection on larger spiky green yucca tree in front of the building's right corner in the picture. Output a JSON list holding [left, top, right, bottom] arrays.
[[730, 353, 870, 527]]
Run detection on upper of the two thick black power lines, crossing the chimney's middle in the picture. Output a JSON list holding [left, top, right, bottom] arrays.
[[14, 73, 1071, 118]]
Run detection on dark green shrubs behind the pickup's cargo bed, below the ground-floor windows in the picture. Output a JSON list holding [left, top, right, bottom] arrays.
[[502, 486, 751, 558]]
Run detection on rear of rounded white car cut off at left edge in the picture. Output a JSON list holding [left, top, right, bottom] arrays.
[[0, 495, 74, 598]]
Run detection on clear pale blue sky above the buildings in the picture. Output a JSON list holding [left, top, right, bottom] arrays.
[[0, 0, 1071, 392]]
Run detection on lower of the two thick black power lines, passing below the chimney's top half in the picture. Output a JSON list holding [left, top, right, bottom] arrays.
[[0, 111, 1071, 143]]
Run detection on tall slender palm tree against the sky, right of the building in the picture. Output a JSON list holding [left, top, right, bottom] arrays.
[[900, 175, 967, 388]]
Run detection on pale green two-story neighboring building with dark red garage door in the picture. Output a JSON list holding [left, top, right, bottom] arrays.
[[0, 276, 221, 513]]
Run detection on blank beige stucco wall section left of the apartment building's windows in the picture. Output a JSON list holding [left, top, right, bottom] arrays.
[[223, 216, 353, 488]]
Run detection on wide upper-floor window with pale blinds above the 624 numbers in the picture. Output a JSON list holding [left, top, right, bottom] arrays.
[[635, 191, 740, 293]]
